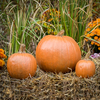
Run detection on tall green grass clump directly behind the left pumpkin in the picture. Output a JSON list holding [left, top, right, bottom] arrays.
[[5, 0, 44, 55]]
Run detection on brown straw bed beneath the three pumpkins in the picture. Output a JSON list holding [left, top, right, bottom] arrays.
[[0, 59, 100, 100]]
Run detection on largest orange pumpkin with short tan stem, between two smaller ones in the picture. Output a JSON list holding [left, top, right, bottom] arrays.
[[36, 30, 81, 73]]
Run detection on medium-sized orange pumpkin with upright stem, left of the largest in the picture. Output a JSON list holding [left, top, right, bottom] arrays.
[[7, 44, 37, 79]]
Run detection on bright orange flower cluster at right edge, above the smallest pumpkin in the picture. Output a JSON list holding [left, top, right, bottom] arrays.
[[85, 18, 100, 50]]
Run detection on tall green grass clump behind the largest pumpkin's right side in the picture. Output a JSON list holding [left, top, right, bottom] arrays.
[[59, 0, 91, 42]]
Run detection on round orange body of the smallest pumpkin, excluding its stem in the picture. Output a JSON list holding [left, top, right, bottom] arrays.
[[75, 59, 95, 78]]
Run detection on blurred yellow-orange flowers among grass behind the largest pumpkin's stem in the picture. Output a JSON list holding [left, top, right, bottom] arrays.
[[41, 9, 61, 35]]
